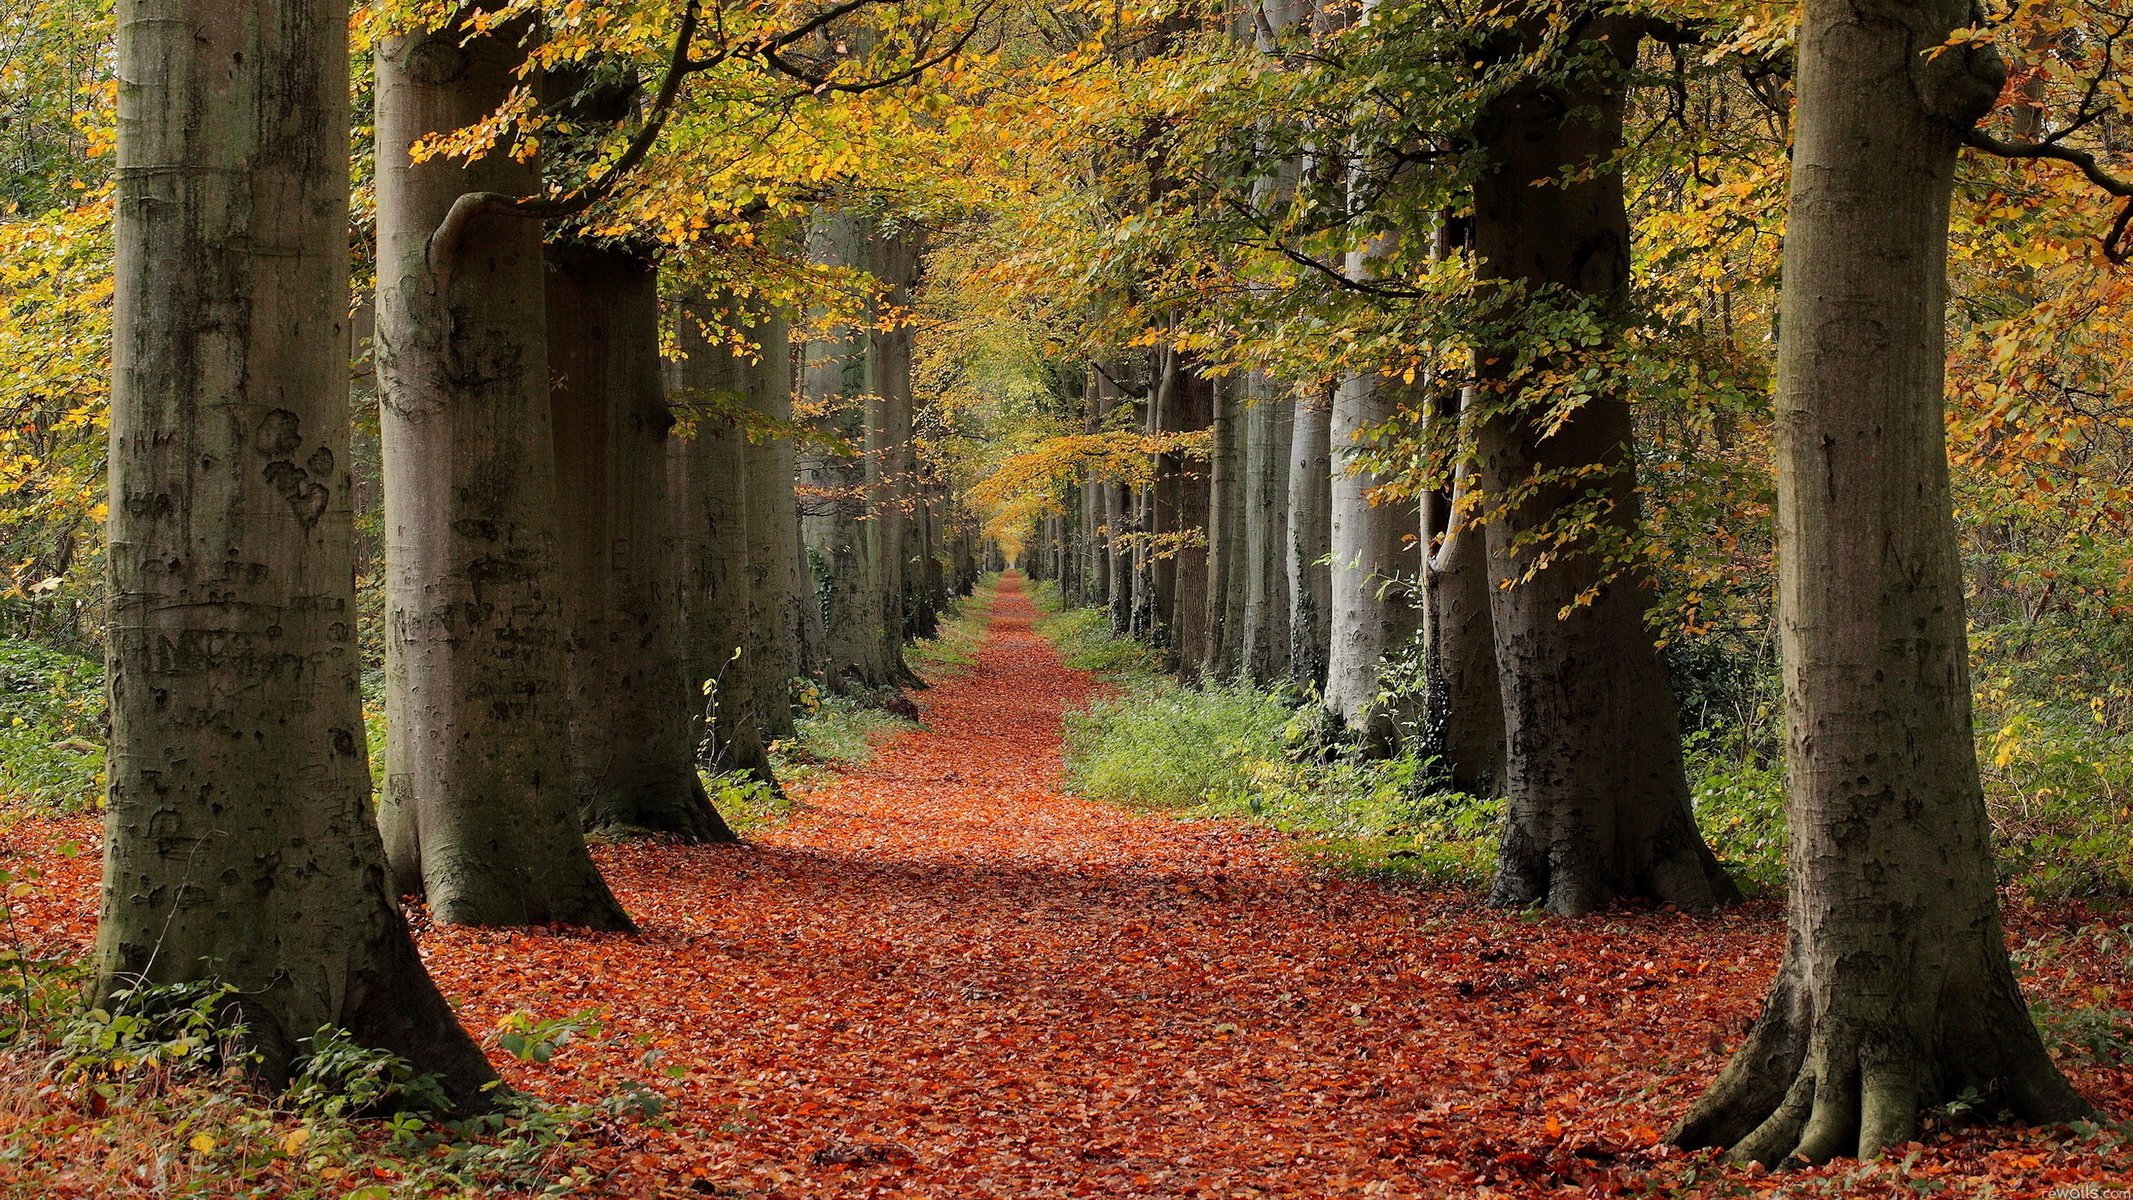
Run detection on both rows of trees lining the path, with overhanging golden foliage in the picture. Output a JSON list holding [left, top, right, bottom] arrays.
[[37, 0, 2118, 1162]]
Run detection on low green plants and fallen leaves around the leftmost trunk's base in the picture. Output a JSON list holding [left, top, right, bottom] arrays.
[[0, 961, 661, 1200]]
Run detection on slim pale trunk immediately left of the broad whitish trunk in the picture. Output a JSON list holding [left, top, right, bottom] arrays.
[[1284, 388, 1333, 691]]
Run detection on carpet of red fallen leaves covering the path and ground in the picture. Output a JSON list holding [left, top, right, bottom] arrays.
[[13, 578, 2133, 1200]]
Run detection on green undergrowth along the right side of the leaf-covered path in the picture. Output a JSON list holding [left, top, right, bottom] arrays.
[[1032, 584, 2133, 902]]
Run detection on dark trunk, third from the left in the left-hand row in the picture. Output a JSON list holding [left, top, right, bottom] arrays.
[[548, 245, 734, 842]]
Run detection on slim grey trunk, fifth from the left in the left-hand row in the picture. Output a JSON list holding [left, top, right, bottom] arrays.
[[740, 313, 813, 740]]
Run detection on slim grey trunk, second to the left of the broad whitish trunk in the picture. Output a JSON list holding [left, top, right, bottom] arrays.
[[1237, 373, 1295, 686]]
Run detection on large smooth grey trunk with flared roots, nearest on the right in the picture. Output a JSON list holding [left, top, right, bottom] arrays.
[[1672, 0, 2095, 1164]]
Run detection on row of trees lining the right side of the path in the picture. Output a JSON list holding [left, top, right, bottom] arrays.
[[989, 0, 2124, 1162]]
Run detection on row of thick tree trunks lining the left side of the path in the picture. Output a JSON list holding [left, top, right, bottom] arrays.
[[98, 0, 979, 1102]]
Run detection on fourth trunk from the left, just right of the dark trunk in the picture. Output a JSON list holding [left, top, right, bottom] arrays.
[[668, 298, 776, 787]]
